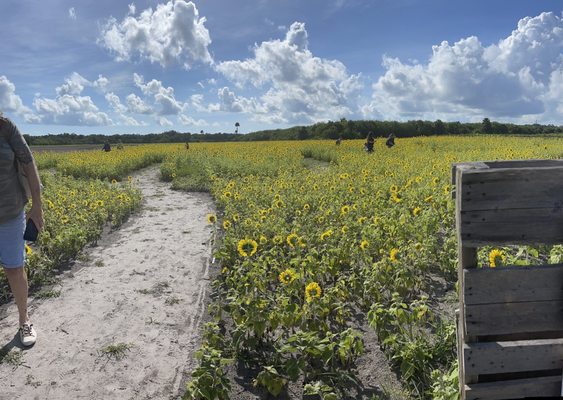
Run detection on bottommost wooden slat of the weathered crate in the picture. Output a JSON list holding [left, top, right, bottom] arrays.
[[465, 376, 561, 400]]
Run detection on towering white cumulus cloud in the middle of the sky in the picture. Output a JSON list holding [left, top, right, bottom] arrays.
[[215, 22, 362, 123]]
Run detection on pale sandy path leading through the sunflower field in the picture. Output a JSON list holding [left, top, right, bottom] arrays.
[[0, 167, 213, 400]]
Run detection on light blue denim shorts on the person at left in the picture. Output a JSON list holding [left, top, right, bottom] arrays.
[[0, 210, 25, 268]]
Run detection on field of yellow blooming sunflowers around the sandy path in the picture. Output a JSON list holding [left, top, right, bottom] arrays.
[[4, 136, 563, 400]]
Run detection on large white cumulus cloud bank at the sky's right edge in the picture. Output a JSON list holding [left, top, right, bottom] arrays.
[[363, 13, 563, 120]]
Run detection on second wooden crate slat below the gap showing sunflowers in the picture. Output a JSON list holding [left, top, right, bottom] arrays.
[[465, 300, 563, 342]]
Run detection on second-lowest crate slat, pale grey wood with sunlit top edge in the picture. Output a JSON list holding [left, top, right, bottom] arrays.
[[463, 339, 563, 375]]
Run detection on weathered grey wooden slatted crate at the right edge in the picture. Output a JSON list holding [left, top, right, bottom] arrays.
[[452, 160, 563, 400]]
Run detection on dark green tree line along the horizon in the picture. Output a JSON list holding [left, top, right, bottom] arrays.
[[24, 118, 563, 145]]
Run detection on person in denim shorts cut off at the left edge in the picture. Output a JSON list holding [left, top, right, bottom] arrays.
[[0, 113, 43, 346]]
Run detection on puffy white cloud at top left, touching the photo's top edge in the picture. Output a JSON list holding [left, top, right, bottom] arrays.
[[98, 0, 213, 69]]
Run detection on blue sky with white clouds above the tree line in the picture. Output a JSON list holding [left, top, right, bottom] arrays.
[[0, 0, 563, 135]]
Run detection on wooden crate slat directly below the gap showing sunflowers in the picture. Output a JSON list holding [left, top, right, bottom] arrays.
[[463, 264, 563, 305]]
